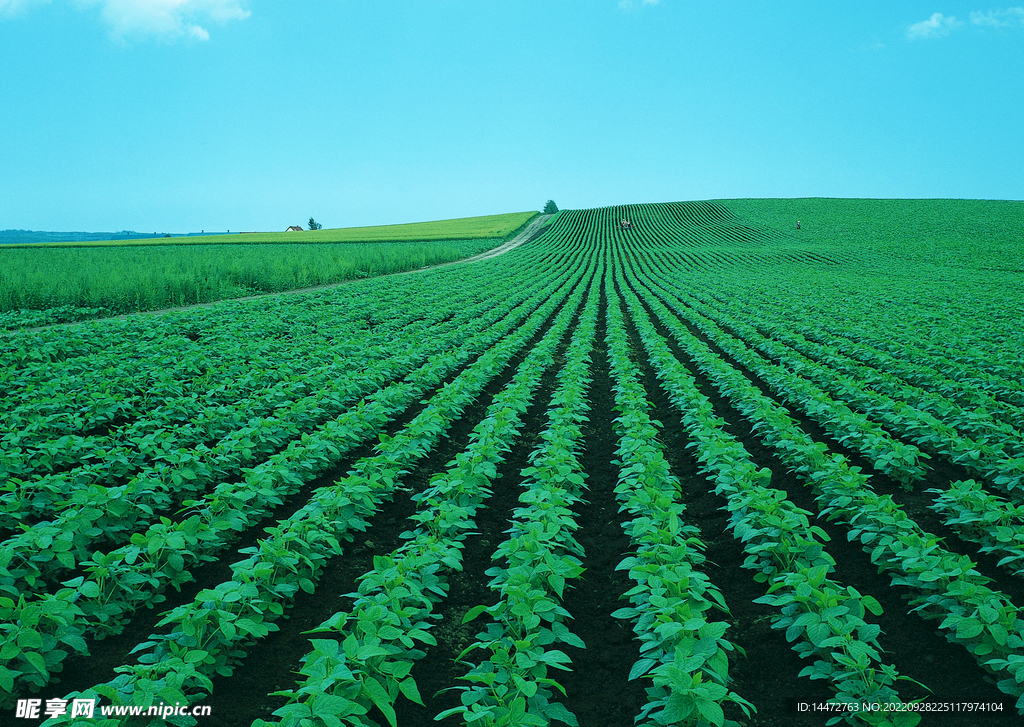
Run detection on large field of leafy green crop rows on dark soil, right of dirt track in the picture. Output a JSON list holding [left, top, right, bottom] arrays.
[[0, 199, 1024, 727]]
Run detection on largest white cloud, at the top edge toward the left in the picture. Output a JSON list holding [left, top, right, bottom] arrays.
[[79, 0, 250, 40]]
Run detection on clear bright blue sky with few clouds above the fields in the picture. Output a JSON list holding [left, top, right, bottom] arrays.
[[0, 0, 1024, 232]]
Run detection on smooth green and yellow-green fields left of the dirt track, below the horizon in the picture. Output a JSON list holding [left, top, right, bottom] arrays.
[[0, 212, 538, 329]]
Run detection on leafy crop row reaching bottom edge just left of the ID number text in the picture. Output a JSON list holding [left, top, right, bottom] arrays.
[[605, 270, 753, 725]]
